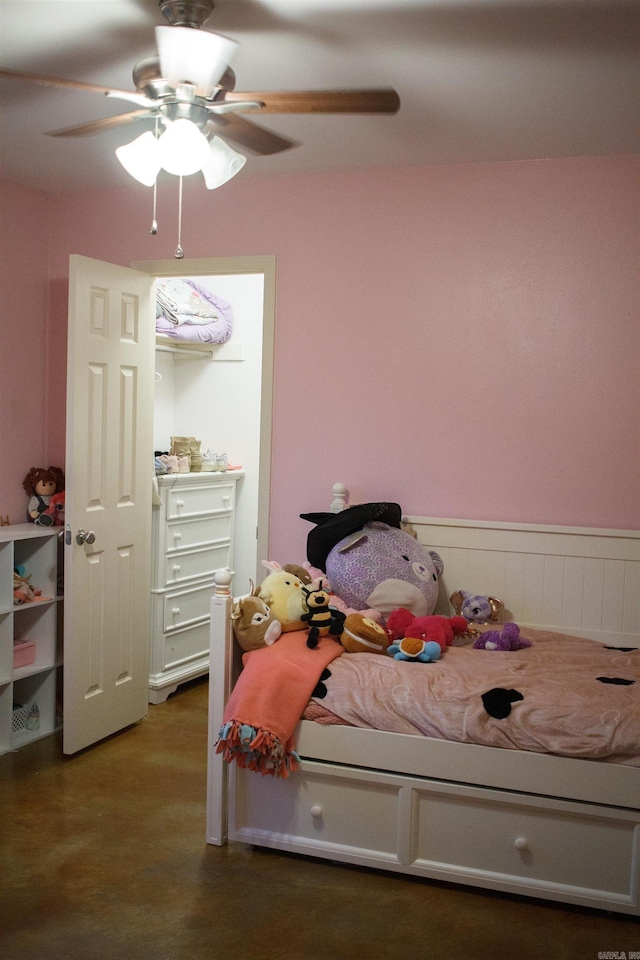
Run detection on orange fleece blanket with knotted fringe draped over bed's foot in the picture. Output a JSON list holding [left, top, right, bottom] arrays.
[[216, 630, 343, 778]]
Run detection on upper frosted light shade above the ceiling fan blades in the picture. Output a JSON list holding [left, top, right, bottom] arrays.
[[156, 27, 238, 90]]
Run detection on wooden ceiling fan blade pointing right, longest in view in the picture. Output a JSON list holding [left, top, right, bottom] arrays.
[[225, 87, 400, 113]]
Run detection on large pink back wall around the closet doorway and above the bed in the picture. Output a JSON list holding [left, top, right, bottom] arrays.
[[0, 156, 640, 562]]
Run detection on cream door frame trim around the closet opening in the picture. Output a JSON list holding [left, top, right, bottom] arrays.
[[130, 255, 276, 576]]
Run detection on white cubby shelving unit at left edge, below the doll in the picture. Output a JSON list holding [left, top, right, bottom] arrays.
[[0, 523, 62, 754]]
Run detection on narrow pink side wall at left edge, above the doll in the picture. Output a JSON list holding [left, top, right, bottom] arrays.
[[0, 181, 51, 523]]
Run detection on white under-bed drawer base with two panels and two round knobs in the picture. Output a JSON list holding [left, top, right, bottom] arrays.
[[229, 761, 640, 913]]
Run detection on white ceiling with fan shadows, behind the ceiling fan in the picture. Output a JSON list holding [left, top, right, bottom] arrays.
[[0, 0, 640, 192]]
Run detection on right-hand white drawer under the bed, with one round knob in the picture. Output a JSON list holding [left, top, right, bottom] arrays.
[[412, 785, 640, 898]]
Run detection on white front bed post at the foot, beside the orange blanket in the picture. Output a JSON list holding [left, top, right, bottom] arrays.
[[207, 570, 233, 846]]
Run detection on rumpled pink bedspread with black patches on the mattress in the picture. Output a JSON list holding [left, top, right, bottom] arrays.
[[306, 630, 640, 766]]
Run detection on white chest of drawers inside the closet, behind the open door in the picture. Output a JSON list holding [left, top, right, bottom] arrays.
[[149, 470, 244, 703]]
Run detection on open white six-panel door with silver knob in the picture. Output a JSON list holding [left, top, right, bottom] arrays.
[[63, 256, 155, 753]]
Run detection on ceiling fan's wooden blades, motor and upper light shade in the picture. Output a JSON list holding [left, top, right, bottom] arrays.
[[0, 0, 400, 155]]
